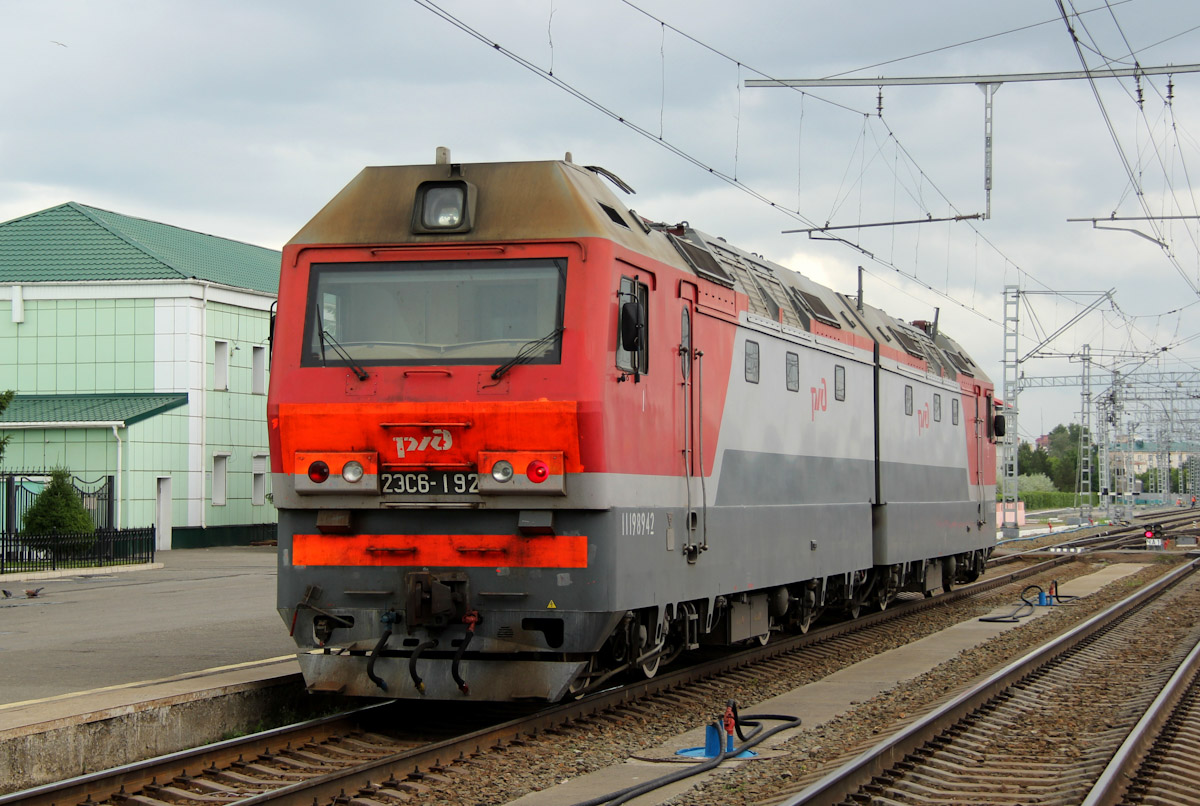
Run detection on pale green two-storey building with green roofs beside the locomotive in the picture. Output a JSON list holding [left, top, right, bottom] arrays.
[[0, 202, 280, 548]]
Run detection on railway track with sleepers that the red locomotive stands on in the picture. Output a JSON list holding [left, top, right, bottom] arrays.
[[0, 555, 1104, 806]]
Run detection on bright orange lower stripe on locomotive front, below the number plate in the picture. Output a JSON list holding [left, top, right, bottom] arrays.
[[292, 535, 588, 569]]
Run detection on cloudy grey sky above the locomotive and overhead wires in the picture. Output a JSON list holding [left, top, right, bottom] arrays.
[[0, 0, 1200, 438]]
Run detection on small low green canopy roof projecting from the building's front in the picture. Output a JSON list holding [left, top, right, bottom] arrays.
[[0, 392, 187, 431]]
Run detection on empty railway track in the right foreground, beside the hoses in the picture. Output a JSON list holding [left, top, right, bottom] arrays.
[[784, 561, 1200, 806]]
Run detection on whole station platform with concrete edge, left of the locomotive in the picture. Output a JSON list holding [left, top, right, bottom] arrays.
[[0, 547, 304, 792]]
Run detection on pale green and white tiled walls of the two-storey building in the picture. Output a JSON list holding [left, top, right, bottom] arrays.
[[0, 281, 277, 548]]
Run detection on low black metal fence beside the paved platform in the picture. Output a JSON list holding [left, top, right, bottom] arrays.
[[0, 527, 155, 573]]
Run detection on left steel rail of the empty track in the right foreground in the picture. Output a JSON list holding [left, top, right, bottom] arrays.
[[781, 560, 1200, 806]]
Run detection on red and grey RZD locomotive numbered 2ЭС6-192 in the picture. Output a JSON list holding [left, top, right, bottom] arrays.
[[268, 150, 1002, 700]]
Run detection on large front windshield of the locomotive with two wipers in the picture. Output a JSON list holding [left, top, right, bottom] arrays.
[[301, 259, 566, 367]]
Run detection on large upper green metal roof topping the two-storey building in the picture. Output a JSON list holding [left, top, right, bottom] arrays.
[[0, 202, 281, 294]]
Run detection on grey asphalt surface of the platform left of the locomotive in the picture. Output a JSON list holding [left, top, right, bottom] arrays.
[[0, 547, 295, 704]]
